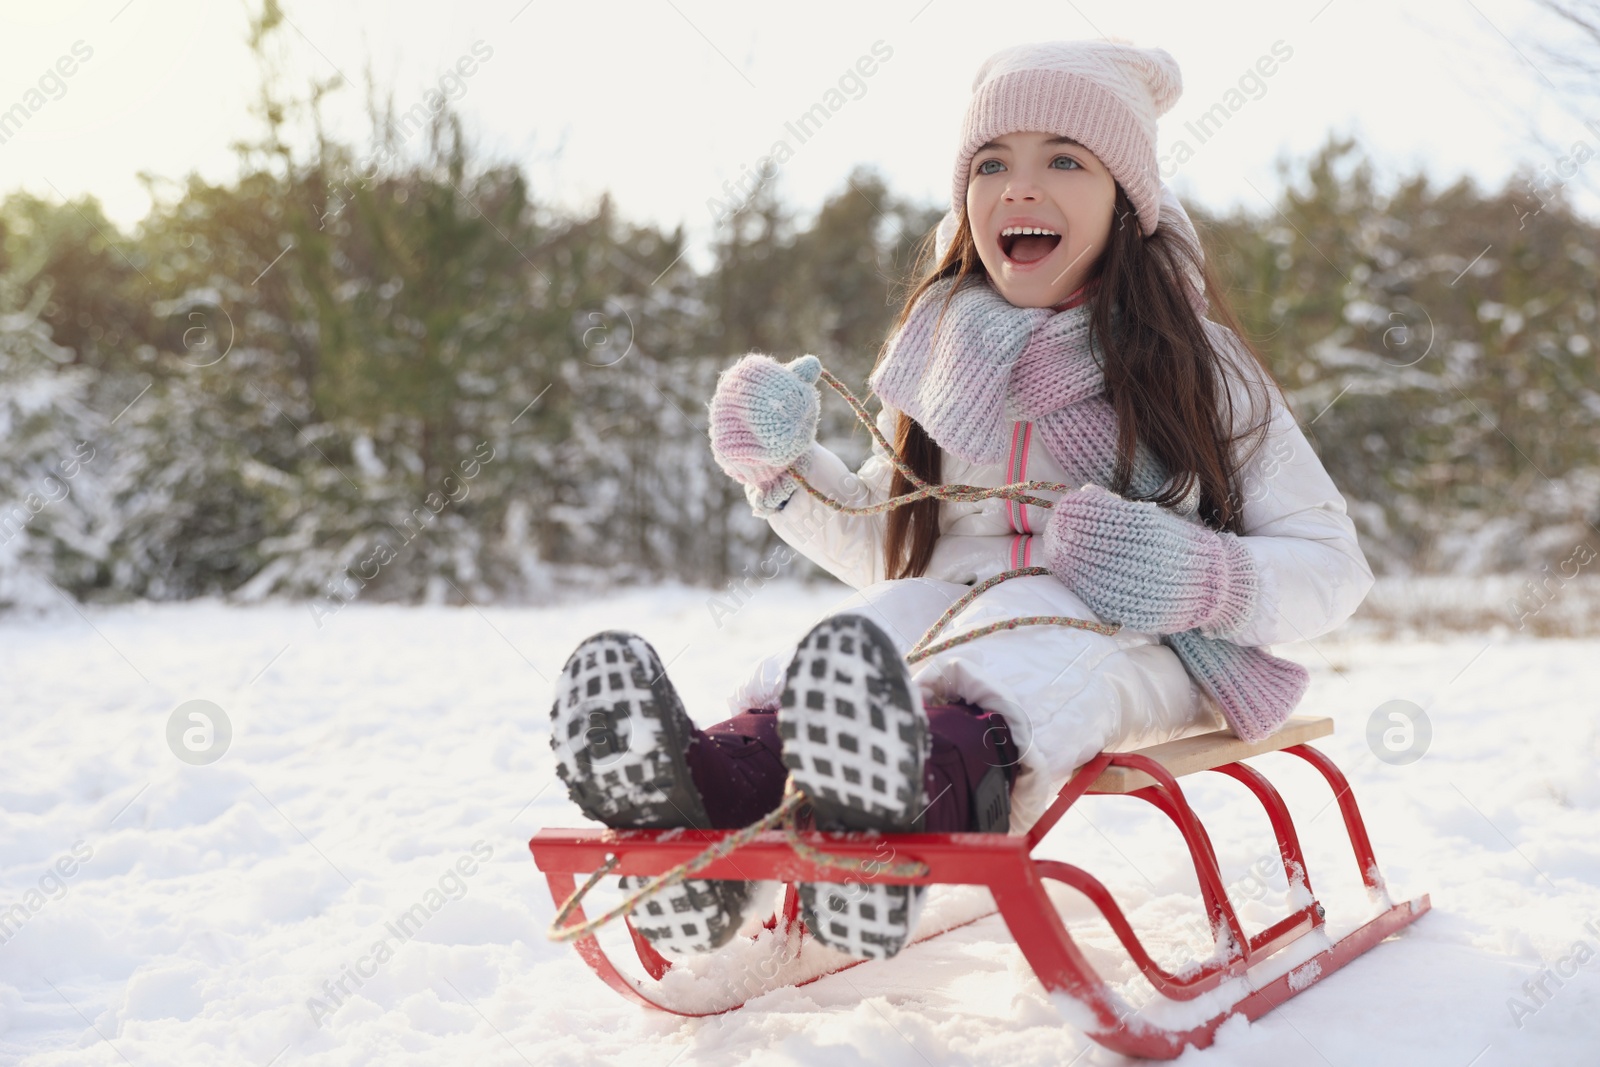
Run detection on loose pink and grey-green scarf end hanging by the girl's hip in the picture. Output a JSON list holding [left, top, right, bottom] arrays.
[[1166, 630, 1310, 741]]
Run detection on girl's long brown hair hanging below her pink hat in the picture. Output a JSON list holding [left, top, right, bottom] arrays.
[[877, 184, 1282, 577]]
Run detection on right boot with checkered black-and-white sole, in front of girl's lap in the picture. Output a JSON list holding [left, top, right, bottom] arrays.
[[778, 614, 931, 958]]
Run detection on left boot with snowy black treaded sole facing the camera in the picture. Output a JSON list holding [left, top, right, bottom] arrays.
[[550, 630, 754, 953]]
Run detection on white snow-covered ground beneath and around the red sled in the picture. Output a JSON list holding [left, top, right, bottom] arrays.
[[0, 585, 1600, 1067]]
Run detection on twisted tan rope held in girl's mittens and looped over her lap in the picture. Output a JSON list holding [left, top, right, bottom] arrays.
[[789, 368, 1122, 664]]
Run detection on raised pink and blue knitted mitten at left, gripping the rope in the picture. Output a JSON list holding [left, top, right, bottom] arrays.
[[709, 352, 822, 515]]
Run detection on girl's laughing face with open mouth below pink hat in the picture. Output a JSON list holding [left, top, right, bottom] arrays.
[[966, 133, 1117, 307]]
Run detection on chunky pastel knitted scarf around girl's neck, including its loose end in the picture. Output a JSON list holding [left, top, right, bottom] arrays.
[[869, 277, 1310, 741]]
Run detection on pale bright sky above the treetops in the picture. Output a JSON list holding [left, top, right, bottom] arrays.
[[0, 0, 1600, 266]]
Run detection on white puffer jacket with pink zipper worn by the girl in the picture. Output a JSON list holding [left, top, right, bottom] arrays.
[[731, 322, 1373, 829]]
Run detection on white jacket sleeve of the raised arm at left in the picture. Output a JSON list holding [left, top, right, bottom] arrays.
[[766, 406, 898, 589]]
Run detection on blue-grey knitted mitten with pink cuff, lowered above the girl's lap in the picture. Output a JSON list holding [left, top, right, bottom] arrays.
[[1043, 485, 1256, 637]]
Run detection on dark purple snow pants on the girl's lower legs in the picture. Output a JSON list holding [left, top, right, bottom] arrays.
[[686, 704, 1019, 833]]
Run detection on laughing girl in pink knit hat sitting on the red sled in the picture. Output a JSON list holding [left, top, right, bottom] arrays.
[[550, 40, 1373, 957]]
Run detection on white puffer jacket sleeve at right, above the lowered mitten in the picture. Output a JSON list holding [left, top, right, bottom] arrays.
[[1206, 322, 1373, 645]]
